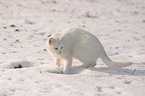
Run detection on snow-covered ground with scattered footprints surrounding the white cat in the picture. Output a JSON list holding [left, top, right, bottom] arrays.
[[0, 0, 145, 96]]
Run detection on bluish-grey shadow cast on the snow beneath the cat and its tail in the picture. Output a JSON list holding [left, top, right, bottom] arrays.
[[70, 67, 145, 76]]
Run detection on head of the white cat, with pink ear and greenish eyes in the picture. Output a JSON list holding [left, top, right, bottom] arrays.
[[47, 37, 64, 56]]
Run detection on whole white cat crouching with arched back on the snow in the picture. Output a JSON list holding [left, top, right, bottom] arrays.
[[47, 28, 132, 74]]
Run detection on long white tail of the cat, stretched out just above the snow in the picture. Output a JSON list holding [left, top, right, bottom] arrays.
[[100, 52, 132, 68]]
